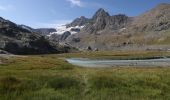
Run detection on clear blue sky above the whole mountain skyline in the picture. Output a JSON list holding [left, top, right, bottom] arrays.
[[0, 0, 170, 28]]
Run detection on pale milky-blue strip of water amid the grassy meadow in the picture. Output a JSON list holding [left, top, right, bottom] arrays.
[[66, 58, 170, 68]]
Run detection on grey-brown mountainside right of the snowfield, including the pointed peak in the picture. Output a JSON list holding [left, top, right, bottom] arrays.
[[66, 4, 170, 50]]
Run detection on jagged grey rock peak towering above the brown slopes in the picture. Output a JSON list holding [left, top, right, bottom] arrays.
[[84, 8, 130, 33]]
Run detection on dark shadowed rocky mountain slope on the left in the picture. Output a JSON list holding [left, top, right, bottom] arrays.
[[0, 17, 70, 54]]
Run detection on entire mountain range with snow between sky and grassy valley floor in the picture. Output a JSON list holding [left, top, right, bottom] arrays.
[[0, 4, 170, 54]]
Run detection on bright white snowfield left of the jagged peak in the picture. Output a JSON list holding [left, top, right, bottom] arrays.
[[48, 25, 84, 36]]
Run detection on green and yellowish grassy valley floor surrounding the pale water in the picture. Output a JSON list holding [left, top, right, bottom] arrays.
[[0, 51, 170, 100]]
